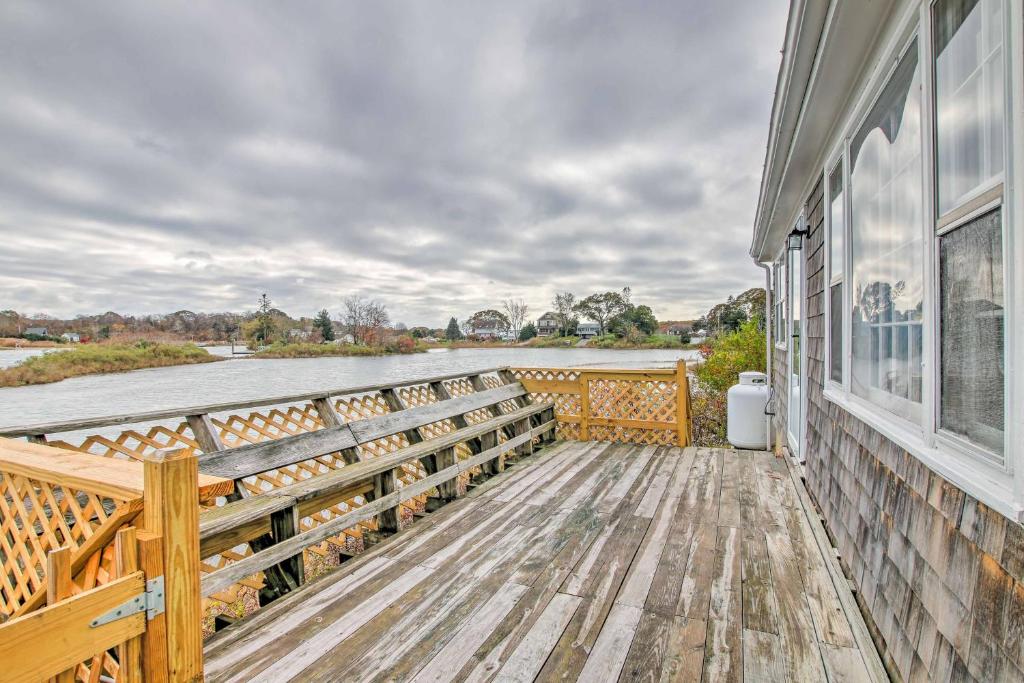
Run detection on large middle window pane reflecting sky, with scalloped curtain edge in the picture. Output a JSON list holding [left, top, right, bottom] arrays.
[[850, 41, 924, 421]]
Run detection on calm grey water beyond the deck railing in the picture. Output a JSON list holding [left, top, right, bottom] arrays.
[[0, 347, 697, 426]]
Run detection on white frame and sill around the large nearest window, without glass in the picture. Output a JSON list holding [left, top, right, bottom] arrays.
[[821, 0, 1024, 520]]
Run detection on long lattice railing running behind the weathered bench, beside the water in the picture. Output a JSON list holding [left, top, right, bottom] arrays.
[[0, 369, 540, 627]]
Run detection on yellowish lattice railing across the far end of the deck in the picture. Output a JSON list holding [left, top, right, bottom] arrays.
[[510, 360, 691, 446]]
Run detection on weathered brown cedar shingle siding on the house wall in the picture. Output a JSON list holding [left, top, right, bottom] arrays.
[[798, 181, 1024, 681]]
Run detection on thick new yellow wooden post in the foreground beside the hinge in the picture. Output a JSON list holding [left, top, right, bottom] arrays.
[[142, 450, 203, 681]]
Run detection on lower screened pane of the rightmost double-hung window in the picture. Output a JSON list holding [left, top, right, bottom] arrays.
[[939, 209, 1006, 454]]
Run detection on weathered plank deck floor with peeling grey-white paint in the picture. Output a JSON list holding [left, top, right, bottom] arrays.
[[206, 441, 884, 681]]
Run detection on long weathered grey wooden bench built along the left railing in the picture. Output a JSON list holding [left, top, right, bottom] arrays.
[[189, 376, 555, 601]]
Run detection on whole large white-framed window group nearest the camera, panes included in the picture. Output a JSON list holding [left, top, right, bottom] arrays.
[[818, 0, 1024, 511]]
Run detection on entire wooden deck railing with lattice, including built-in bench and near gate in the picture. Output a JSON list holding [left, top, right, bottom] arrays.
[[0, 364, 689, 681]]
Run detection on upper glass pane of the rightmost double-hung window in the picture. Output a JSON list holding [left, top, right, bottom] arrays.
[[933, 0, 1005, 215]]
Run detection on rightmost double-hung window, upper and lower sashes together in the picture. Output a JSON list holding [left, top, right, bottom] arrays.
[[932, 0, 1007, 462]]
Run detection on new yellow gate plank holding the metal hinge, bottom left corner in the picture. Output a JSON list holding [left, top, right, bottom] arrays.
[[0, 571, 145, 681]]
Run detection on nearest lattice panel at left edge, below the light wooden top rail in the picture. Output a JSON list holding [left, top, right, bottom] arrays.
[[0, 472, 118, 616]]
